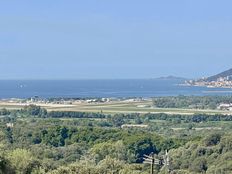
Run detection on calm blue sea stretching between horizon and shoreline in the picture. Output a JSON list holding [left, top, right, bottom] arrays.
[[0, 79, 232, 98]]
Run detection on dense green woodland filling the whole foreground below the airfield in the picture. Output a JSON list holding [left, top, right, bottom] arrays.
[[0, 105, 232, 174]]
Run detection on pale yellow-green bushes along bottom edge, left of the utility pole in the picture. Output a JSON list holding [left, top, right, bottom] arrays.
[[0, 149, 148, 174]]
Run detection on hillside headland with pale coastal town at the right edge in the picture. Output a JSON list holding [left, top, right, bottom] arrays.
[[185, 69, 232, 88]]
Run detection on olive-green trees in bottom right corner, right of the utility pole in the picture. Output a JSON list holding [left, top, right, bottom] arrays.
[[170, 133, 232, 174]]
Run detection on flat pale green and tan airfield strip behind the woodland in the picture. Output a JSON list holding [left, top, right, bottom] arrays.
[[0, 101, 232, 115]]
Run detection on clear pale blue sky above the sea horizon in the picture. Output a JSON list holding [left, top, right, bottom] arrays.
[[0, 0, 232, 79]]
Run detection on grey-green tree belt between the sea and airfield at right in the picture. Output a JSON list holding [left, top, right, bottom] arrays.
[[153, 96, 232, 109]]
